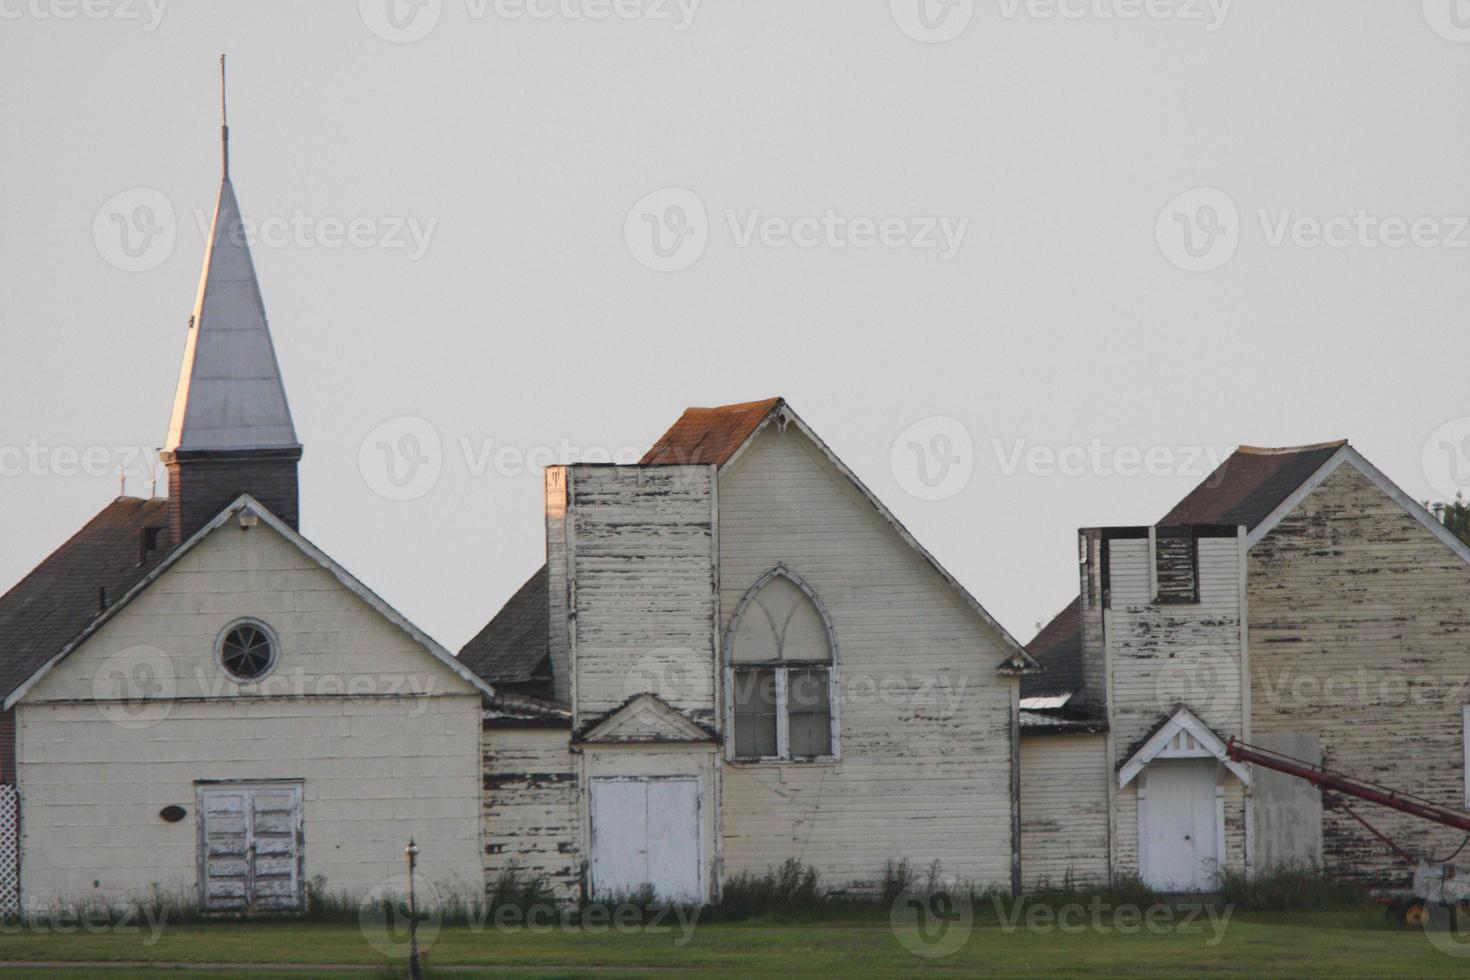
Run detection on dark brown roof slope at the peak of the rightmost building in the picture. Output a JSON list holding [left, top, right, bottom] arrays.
[[1158, 439, 1347, 530]]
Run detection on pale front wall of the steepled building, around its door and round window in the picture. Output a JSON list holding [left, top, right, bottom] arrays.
[[16, 525, 481, 904]]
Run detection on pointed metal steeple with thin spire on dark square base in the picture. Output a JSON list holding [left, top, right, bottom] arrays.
[[162, 56, 301, 541]]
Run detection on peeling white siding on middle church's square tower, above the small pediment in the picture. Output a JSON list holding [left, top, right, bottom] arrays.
[[567, 466, 716, 724]]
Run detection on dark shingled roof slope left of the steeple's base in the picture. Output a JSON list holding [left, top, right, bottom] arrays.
[[0, 497, 176, 698]]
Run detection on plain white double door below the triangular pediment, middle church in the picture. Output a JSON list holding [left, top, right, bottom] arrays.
[[591, 776, 704, 902]]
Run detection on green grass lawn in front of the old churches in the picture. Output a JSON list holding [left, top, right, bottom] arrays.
[[0, 908, 1470, 980]]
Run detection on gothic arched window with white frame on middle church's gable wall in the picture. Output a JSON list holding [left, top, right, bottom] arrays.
[[725, 566, 836, 761]]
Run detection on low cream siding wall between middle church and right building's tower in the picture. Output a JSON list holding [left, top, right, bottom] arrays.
[[1020, 735, 1110, 889]]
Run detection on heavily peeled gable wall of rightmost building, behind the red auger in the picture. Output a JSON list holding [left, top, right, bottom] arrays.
[[1247, 466, 1470, 886]]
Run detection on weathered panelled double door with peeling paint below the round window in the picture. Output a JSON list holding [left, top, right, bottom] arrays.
[[198, 783, 304, 912]]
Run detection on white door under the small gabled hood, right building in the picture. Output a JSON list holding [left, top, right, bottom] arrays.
[[1138, 760, 1220, 892]]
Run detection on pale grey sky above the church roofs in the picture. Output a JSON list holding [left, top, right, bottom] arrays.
[[0, 0, 1470, 649]]
